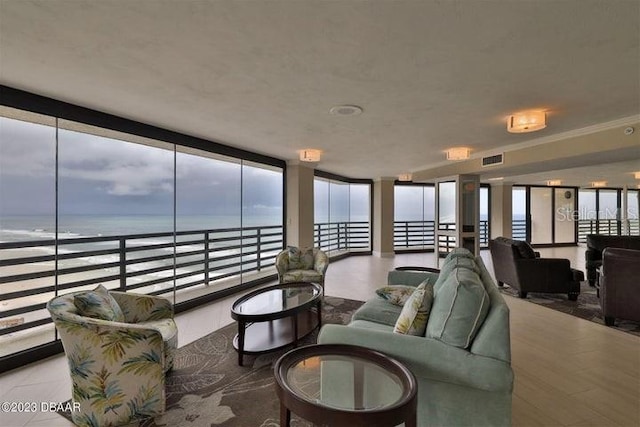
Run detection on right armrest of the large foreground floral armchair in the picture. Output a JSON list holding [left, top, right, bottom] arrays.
[[109, 291, 173, 323]]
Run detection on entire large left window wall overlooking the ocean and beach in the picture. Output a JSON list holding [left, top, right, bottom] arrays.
[[0, 93, 284, 372]]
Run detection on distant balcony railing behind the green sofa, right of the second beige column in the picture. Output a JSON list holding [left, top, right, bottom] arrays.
[[393, 220, 489, 250]]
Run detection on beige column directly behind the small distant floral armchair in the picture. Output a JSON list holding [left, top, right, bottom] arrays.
[[286, 163, 314, 248]]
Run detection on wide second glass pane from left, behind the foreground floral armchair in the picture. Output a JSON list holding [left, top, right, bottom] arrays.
[[58, 122, 174, 300]]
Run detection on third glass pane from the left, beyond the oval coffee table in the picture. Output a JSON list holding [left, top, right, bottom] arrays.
[[176, 148, 242, 302]]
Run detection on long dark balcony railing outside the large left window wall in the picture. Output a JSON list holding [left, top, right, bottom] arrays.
[[0, 226, 283, 337]]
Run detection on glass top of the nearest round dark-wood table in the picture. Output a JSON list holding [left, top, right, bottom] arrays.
[[284, 354, 405, 411]]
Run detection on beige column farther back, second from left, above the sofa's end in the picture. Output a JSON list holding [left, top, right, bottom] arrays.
[[373, 178, 395, 258]]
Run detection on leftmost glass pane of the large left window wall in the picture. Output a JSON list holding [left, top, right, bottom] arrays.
[[0, 109, 56, 357]]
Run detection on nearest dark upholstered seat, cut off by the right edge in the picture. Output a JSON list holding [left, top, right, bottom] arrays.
[[600, 248, 640, 326]]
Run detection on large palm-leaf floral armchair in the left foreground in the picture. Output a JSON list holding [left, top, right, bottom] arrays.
[[47, 286, 178, 426]]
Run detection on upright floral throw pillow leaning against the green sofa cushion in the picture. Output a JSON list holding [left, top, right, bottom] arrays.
[[393, 282, 433, 336]]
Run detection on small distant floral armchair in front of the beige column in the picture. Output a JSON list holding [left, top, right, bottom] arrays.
[[276, 246, 329, 288]]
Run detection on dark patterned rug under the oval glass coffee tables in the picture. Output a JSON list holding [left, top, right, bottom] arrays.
[[60, 296, 363, 427]]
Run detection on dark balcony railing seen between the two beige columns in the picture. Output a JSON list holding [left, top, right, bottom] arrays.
[[313, 221, 371, 252]]
